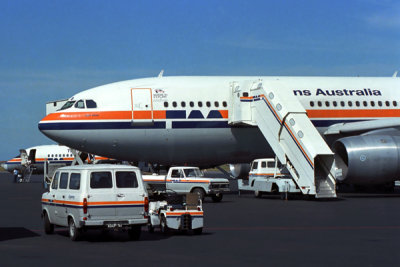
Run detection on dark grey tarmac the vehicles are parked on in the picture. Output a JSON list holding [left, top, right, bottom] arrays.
[[0, 173, 400, 267]]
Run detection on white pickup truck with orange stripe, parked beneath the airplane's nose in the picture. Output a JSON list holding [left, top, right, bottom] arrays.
[[142, 166, 229, 202]]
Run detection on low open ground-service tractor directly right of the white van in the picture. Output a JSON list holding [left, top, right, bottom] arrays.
[[148, 192, 203, 234]]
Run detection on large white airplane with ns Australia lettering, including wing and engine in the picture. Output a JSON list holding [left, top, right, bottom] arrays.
[[38, 74, 400, 187]]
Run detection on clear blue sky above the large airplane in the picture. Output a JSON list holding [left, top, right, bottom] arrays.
[[0, 0, 400, 160]]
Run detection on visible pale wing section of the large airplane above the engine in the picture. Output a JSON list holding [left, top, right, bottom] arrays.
[[324, 118, 400, 135]]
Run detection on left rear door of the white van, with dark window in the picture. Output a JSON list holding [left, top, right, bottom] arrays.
[[87, 171, 116, 220]]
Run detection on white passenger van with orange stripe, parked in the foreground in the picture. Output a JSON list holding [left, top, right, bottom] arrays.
[[42, 164, 149, 240]]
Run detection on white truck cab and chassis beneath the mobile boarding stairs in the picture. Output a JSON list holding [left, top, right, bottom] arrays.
[[238, 158, 301, 199]]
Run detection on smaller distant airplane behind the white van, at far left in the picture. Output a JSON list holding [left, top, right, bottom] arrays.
[[0, 145, 107, 174]]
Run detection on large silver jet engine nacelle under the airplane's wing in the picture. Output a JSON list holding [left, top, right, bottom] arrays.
[[333, 135, 400, 185]]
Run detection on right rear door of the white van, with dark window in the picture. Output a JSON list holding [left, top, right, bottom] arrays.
[[115, 170, 145, 220]]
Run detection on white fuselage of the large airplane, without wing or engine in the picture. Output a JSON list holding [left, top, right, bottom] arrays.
[[39, 77, 400, 166]]
